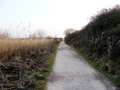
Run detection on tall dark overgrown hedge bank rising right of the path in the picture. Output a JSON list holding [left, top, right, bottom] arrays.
[[65, 6, 120, 87]]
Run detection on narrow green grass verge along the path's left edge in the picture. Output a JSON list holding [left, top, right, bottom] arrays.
[[34, 44, 59, 90]]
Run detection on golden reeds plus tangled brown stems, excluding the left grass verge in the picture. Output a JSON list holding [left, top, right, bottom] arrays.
[[0, 39, 59, 90]]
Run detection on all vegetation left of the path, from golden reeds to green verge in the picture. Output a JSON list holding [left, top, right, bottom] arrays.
[[0, 29, 62, 90]]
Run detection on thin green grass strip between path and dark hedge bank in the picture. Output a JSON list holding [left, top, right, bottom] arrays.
[[67, 44, 120, 88]]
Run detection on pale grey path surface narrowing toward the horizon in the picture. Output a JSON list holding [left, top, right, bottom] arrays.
[[47, 42, 115, 90]]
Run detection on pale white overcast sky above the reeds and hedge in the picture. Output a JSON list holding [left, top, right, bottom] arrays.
[[0, 0, 120, 37]]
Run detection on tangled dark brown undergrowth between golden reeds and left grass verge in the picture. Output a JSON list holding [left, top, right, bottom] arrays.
[[0, 38, 62, 90]]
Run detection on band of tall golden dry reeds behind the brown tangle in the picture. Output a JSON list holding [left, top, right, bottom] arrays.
[[0, 38, 52, 60]]
